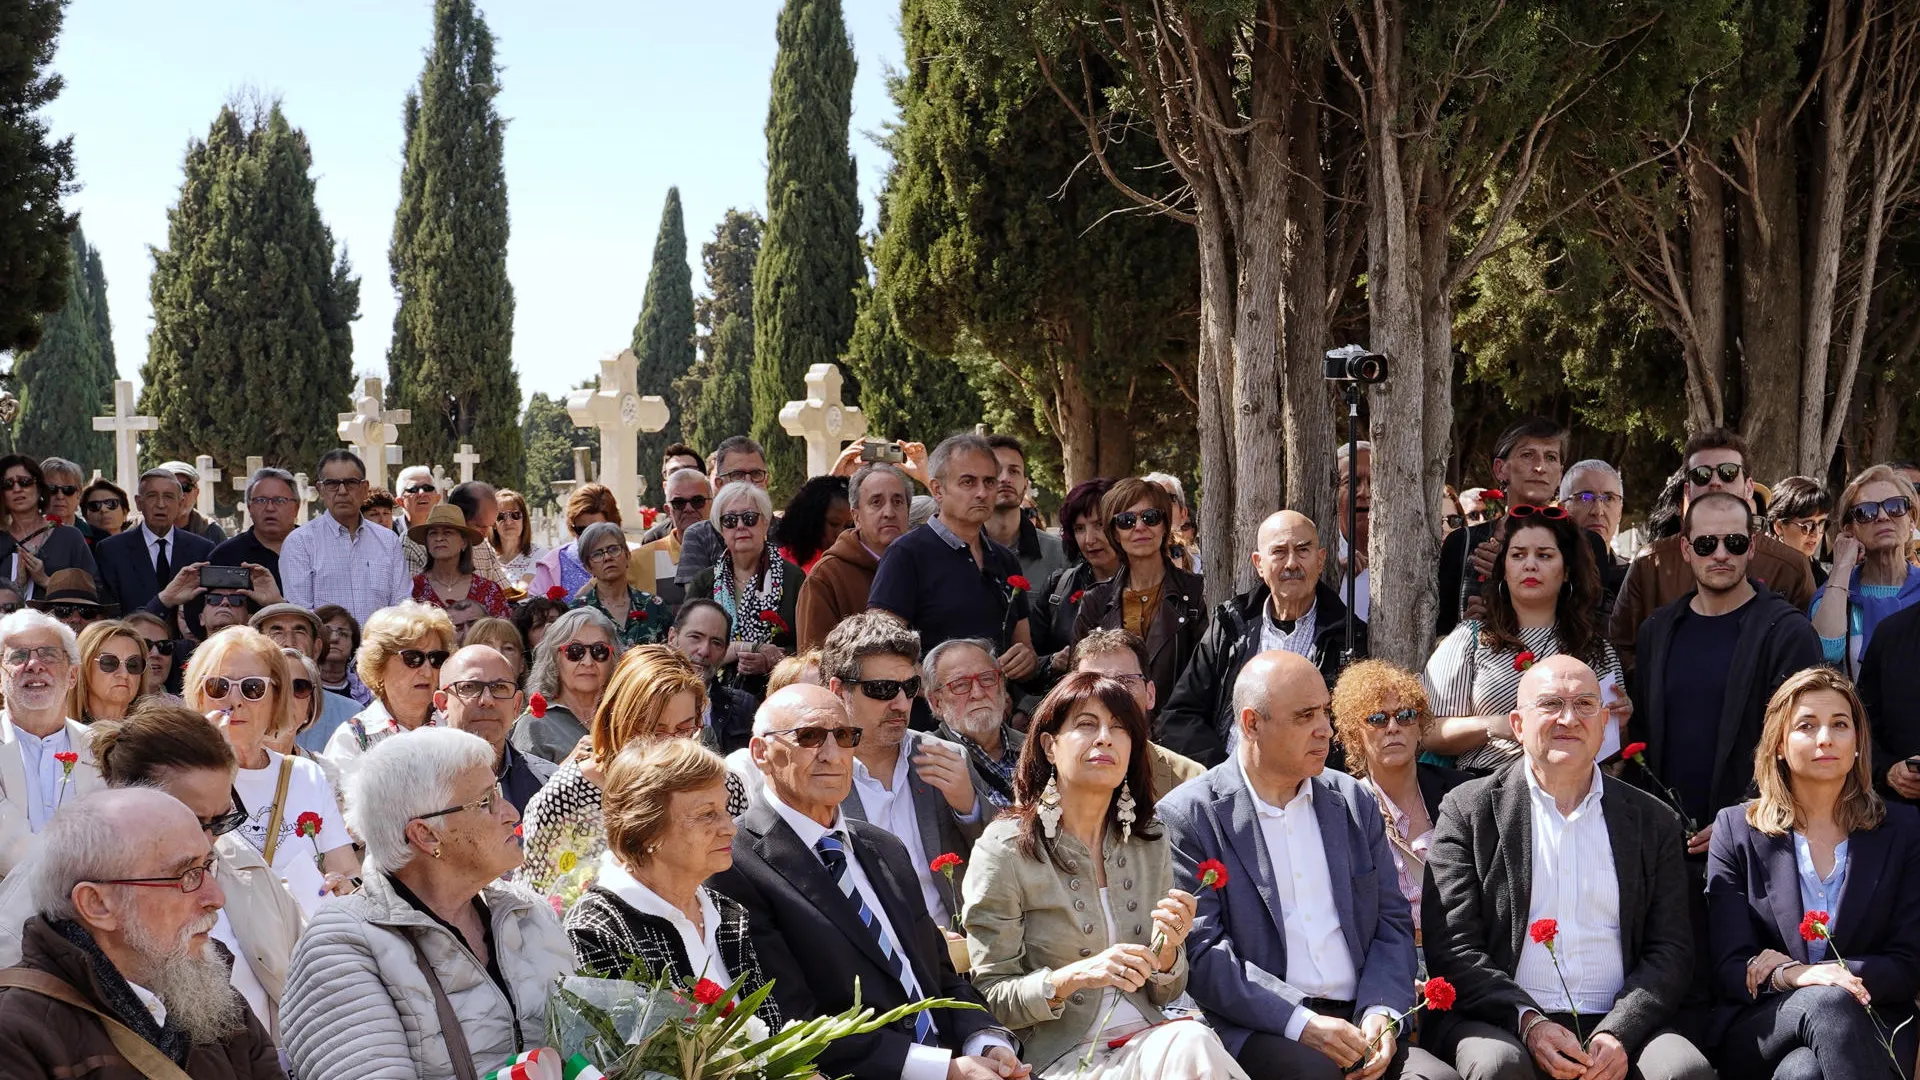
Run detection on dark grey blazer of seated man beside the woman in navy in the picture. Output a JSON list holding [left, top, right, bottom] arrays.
[[1421, 757, 1693, 1055]]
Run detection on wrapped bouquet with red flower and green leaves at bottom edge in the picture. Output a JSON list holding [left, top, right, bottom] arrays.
[[547, 963, 977, 1080]]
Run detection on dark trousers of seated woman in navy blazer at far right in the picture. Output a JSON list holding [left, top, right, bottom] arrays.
[[1720, 986, 1914, 1080]]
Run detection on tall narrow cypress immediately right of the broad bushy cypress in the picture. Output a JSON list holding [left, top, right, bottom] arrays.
[[388, 0, 524, 482]]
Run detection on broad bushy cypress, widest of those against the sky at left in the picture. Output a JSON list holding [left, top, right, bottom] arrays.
[[140, 102, 359, 469]]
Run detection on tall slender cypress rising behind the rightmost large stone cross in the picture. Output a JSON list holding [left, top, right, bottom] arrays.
[[753, 0, 866, 496]]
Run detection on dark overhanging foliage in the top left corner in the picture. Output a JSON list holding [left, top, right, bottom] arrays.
[[0, 0, 75, 350]]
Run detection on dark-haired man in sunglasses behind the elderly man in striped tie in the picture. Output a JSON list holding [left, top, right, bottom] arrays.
[[820, 609, 987, 926]]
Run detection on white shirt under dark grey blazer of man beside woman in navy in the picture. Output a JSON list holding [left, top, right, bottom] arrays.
[[1513, 763, 1626, 1017]]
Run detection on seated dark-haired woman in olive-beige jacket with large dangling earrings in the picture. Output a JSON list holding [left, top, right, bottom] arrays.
[[962, 673, 1246, 1080]]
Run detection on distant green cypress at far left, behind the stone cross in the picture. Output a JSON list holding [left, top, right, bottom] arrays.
[[12, 229, 115, 469]]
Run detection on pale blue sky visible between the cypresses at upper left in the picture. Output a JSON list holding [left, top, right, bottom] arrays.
[[46, 0, 902, 396]]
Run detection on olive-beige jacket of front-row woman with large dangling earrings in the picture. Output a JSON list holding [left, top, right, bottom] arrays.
[[960, 817, 1187, 1074]]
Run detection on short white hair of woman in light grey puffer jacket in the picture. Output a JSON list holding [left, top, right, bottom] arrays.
[[348, 726, 493, 871]]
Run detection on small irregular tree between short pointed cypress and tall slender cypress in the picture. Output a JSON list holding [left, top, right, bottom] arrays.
[[672, 209, 766, 454]]
